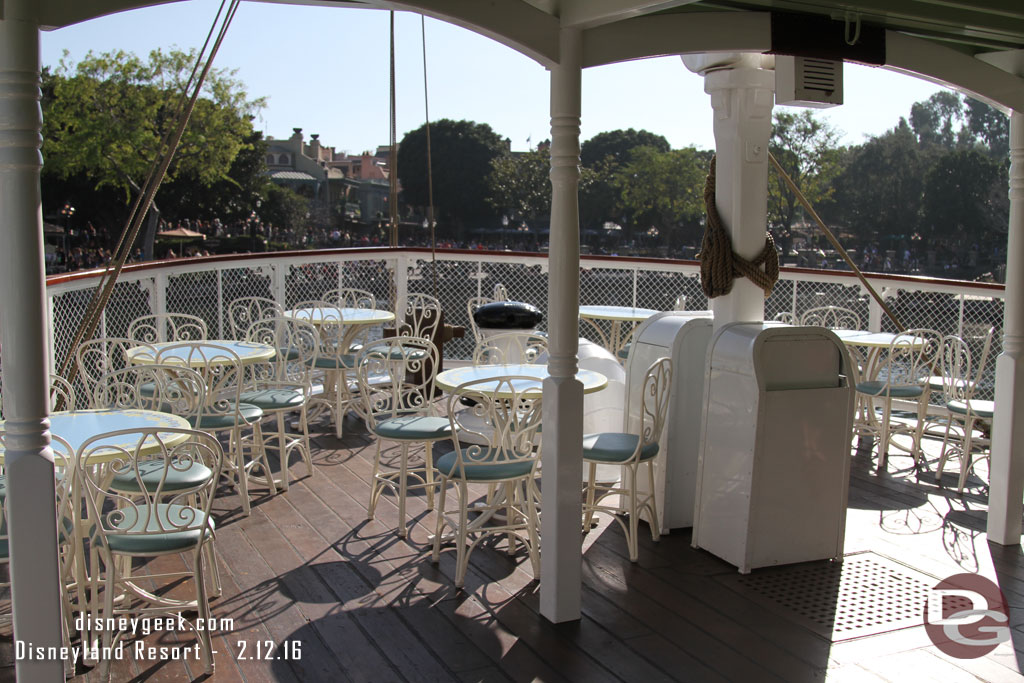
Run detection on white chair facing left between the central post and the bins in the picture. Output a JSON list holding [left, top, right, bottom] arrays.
[[583, 357, 672, 562]]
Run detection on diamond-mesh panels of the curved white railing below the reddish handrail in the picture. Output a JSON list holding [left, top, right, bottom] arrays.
[[46, 254, 1002, 385]]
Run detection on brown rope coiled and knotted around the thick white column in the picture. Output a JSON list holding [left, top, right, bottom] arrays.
[[697, 157, 778, 299]]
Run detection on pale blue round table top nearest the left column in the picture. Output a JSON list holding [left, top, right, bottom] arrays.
[[0, 409, 191, 462]]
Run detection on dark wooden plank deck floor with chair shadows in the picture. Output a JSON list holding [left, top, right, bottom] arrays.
[[0, 413, 1024, 683]]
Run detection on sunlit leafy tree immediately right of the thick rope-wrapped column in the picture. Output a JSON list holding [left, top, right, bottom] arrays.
[[768, 110, 840, 231]]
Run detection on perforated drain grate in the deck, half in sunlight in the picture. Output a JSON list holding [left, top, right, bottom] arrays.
[[719, 552, 938, 642]]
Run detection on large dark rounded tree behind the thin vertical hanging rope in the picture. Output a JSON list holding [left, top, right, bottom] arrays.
[[398, 119, 507, 237]]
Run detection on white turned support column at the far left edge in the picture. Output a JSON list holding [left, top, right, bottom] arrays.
[[0, 0, 63, 681]]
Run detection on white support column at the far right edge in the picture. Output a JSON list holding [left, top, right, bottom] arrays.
[[988, 112, 1024, 546]]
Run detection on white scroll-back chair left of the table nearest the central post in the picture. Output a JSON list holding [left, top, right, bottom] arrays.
[[356, 337, 452, 537]]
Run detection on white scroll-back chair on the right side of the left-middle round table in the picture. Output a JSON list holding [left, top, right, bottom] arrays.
[[239, 317, 319, 490]]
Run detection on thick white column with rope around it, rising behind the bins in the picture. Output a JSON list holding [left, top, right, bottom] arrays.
[[683, 53, 775, 329]]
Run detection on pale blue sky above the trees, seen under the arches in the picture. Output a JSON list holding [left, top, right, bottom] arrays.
[[42, 0, 938, 154]]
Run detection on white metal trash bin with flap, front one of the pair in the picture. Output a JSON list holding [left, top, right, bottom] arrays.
[[693, 323, 854, 573]]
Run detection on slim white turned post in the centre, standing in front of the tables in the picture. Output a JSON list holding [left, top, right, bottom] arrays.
[[541, 29, 583, 623]]
